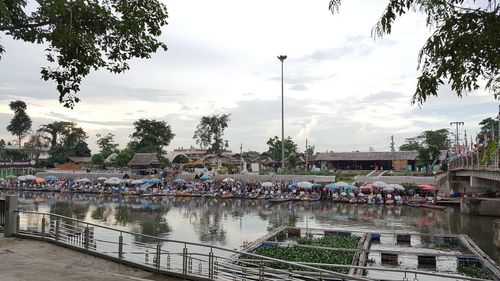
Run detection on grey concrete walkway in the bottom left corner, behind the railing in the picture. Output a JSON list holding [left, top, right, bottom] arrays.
[[0, 233, 184, 281]]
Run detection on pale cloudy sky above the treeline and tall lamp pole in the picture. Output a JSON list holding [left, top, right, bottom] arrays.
[[0, 0, 498, 152]]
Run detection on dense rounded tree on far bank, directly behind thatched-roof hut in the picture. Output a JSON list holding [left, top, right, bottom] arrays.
[[128, 119, 175, 155]]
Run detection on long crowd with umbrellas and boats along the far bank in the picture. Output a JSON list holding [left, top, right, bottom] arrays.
[[0, 176, 434, 205]]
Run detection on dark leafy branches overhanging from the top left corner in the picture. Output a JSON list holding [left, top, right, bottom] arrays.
[[0, 0, 168, 108]]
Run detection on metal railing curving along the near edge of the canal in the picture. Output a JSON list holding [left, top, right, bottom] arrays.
[[12, 210, 496, 281]]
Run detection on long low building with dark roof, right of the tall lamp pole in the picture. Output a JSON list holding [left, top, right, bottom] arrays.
[[314, 150, 447, 171]]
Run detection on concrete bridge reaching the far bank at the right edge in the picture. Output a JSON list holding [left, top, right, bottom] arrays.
[[448, 151, 500, 193]]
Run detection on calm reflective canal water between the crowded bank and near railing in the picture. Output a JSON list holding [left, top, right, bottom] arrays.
[[4, 191, 500, 263]]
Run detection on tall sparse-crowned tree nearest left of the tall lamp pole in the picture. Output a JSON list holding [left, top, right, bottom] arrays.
[[193, 114, 231, 154]]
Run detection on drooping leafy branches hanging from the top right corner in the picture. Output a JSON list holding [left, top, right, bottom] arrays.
[[329, 0, 500, 104]]
